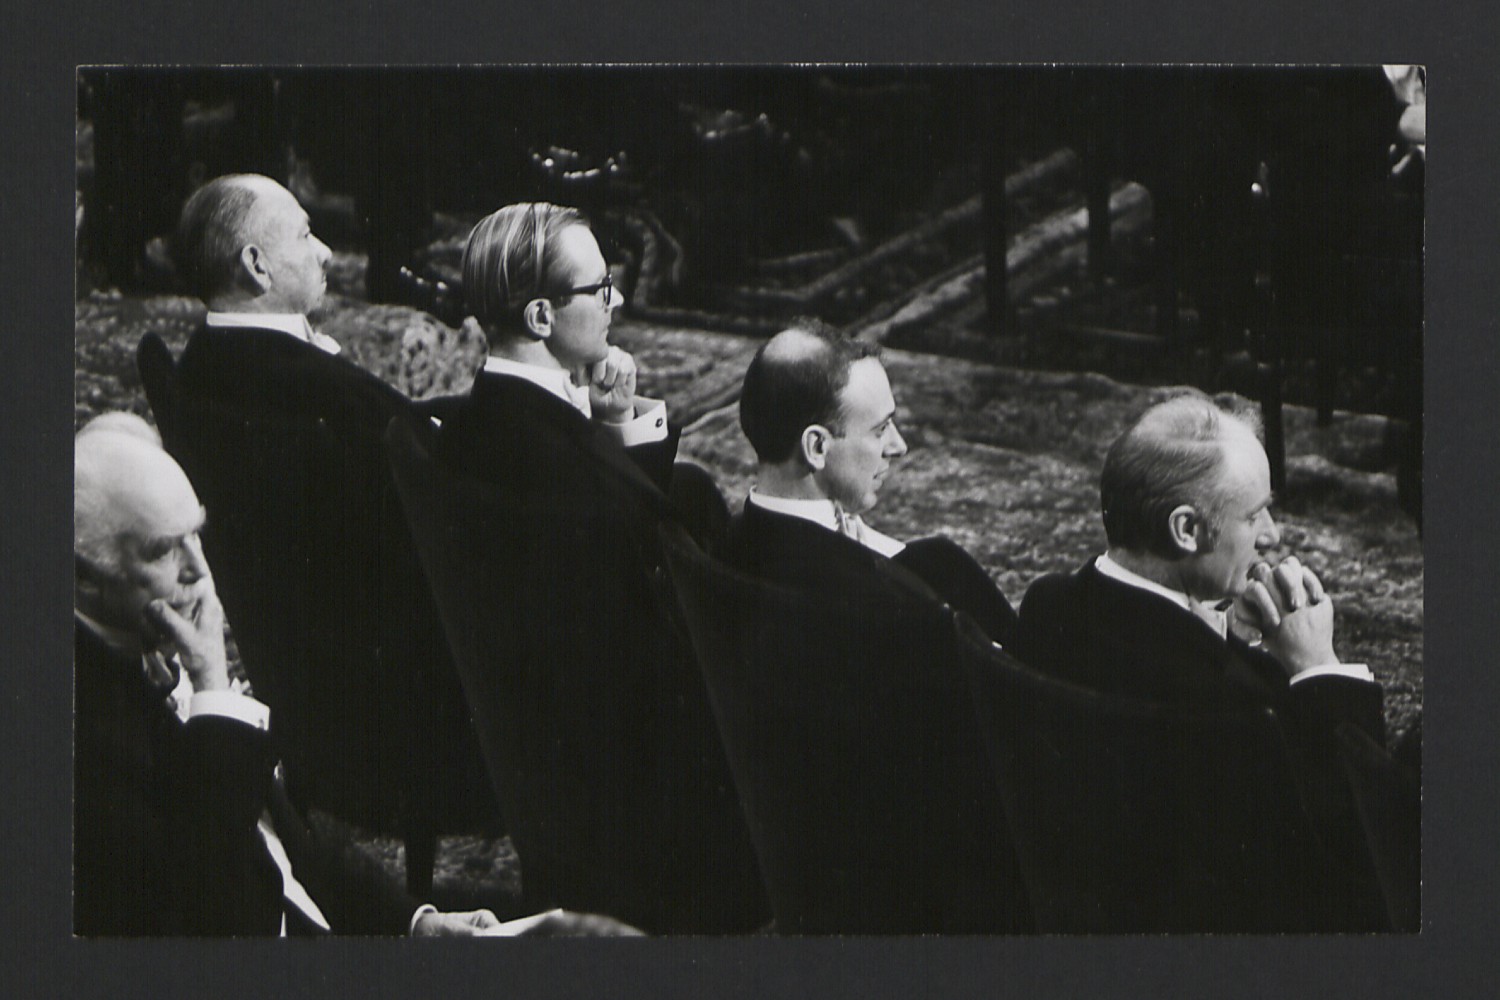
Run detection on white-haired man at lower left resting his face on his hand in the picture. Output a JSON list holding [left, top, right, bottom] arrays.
[[74, 415, 639, 936]]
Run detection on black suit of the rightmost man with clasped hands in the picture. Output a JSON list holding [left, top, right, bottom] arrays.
[[1013, 561, 1385, 929]]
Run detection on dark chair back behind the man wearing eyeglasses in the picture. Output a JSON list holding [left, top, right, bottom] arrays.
[[387, 418, 770, 934]]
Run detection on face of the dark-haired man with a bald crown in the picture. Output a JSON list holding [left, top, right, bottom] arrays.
[[804, 358, 906, 514]]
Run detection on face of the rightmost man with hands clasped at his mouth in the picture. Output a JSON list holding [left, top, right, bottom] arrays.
[[1182, 424, 1281, 601]]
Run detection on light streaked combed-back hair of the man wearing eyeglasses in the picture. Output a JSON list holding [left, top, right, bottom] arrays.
[[464, 201, 588, 334]]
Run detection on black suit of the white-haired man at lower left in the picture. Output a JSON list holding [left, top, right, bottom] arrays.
[[74, 624, 417, 936]]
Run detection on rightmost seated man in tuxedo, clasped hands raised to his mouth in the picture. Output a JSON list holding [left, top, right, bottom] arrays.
[[1013, 393, 1385, 923]]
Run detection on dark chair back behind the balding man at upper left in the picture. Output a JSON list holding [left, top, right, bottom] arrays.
[[140, 336, 500, 834]]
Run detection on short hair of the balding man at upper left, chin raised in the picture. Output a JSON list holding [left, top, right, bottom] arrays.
[[173, 174, 275, 301]]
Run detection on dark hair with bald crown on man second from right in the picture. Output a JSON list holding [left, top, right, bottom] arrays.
[[740, 319, 881, 465]]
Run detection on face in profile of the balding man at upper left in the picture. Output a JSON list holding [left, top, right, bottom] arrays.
[[246, 178, 333, 315]]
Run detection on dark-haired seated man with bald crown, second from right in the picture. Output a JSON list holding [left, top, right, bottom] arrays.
[[717, 322, 1016, 645]]
